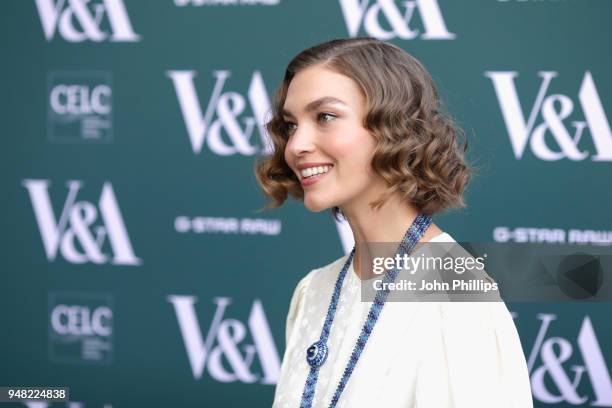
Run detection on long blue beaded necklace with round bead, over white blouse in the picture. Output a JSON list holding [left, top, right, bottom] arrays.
[[300, 214, 431, 408]]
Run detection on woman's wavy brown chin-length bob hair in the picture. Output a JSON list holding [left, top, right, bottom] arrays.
[[254, 37, 471, 220]]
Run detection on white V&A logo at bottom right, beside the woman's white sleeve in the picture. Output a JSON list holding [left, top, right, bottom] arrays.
[[527, 313, 612, 407]]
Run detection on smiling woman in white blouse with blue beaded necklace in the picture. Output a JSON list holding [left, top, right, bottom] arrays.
[[256, 38, 532, 408]]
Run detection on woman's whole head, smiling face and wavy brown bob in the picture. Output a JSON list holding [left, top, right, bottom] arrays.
[[256, 39, 470, 223]]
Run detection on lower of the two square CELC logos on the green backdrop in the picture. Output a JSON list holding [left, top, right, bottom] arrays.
[[49, 292, 113, 364]]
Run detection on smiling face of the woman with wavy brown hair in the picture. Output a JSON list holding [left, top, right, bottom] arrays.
[[284, 65, 382, 213]]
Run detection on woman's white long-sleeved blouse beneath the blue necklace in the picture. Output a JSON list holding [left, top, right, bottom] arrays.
[[273, 233, 533, 408]]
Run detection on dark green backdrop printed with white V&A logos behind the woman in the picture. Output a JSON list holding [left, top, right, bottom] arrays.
[[0, 0, 612, 407]]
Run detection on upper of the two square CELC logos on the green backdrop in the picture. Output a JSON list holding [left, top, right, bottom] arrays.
[[47, 71, 113, 142]]
